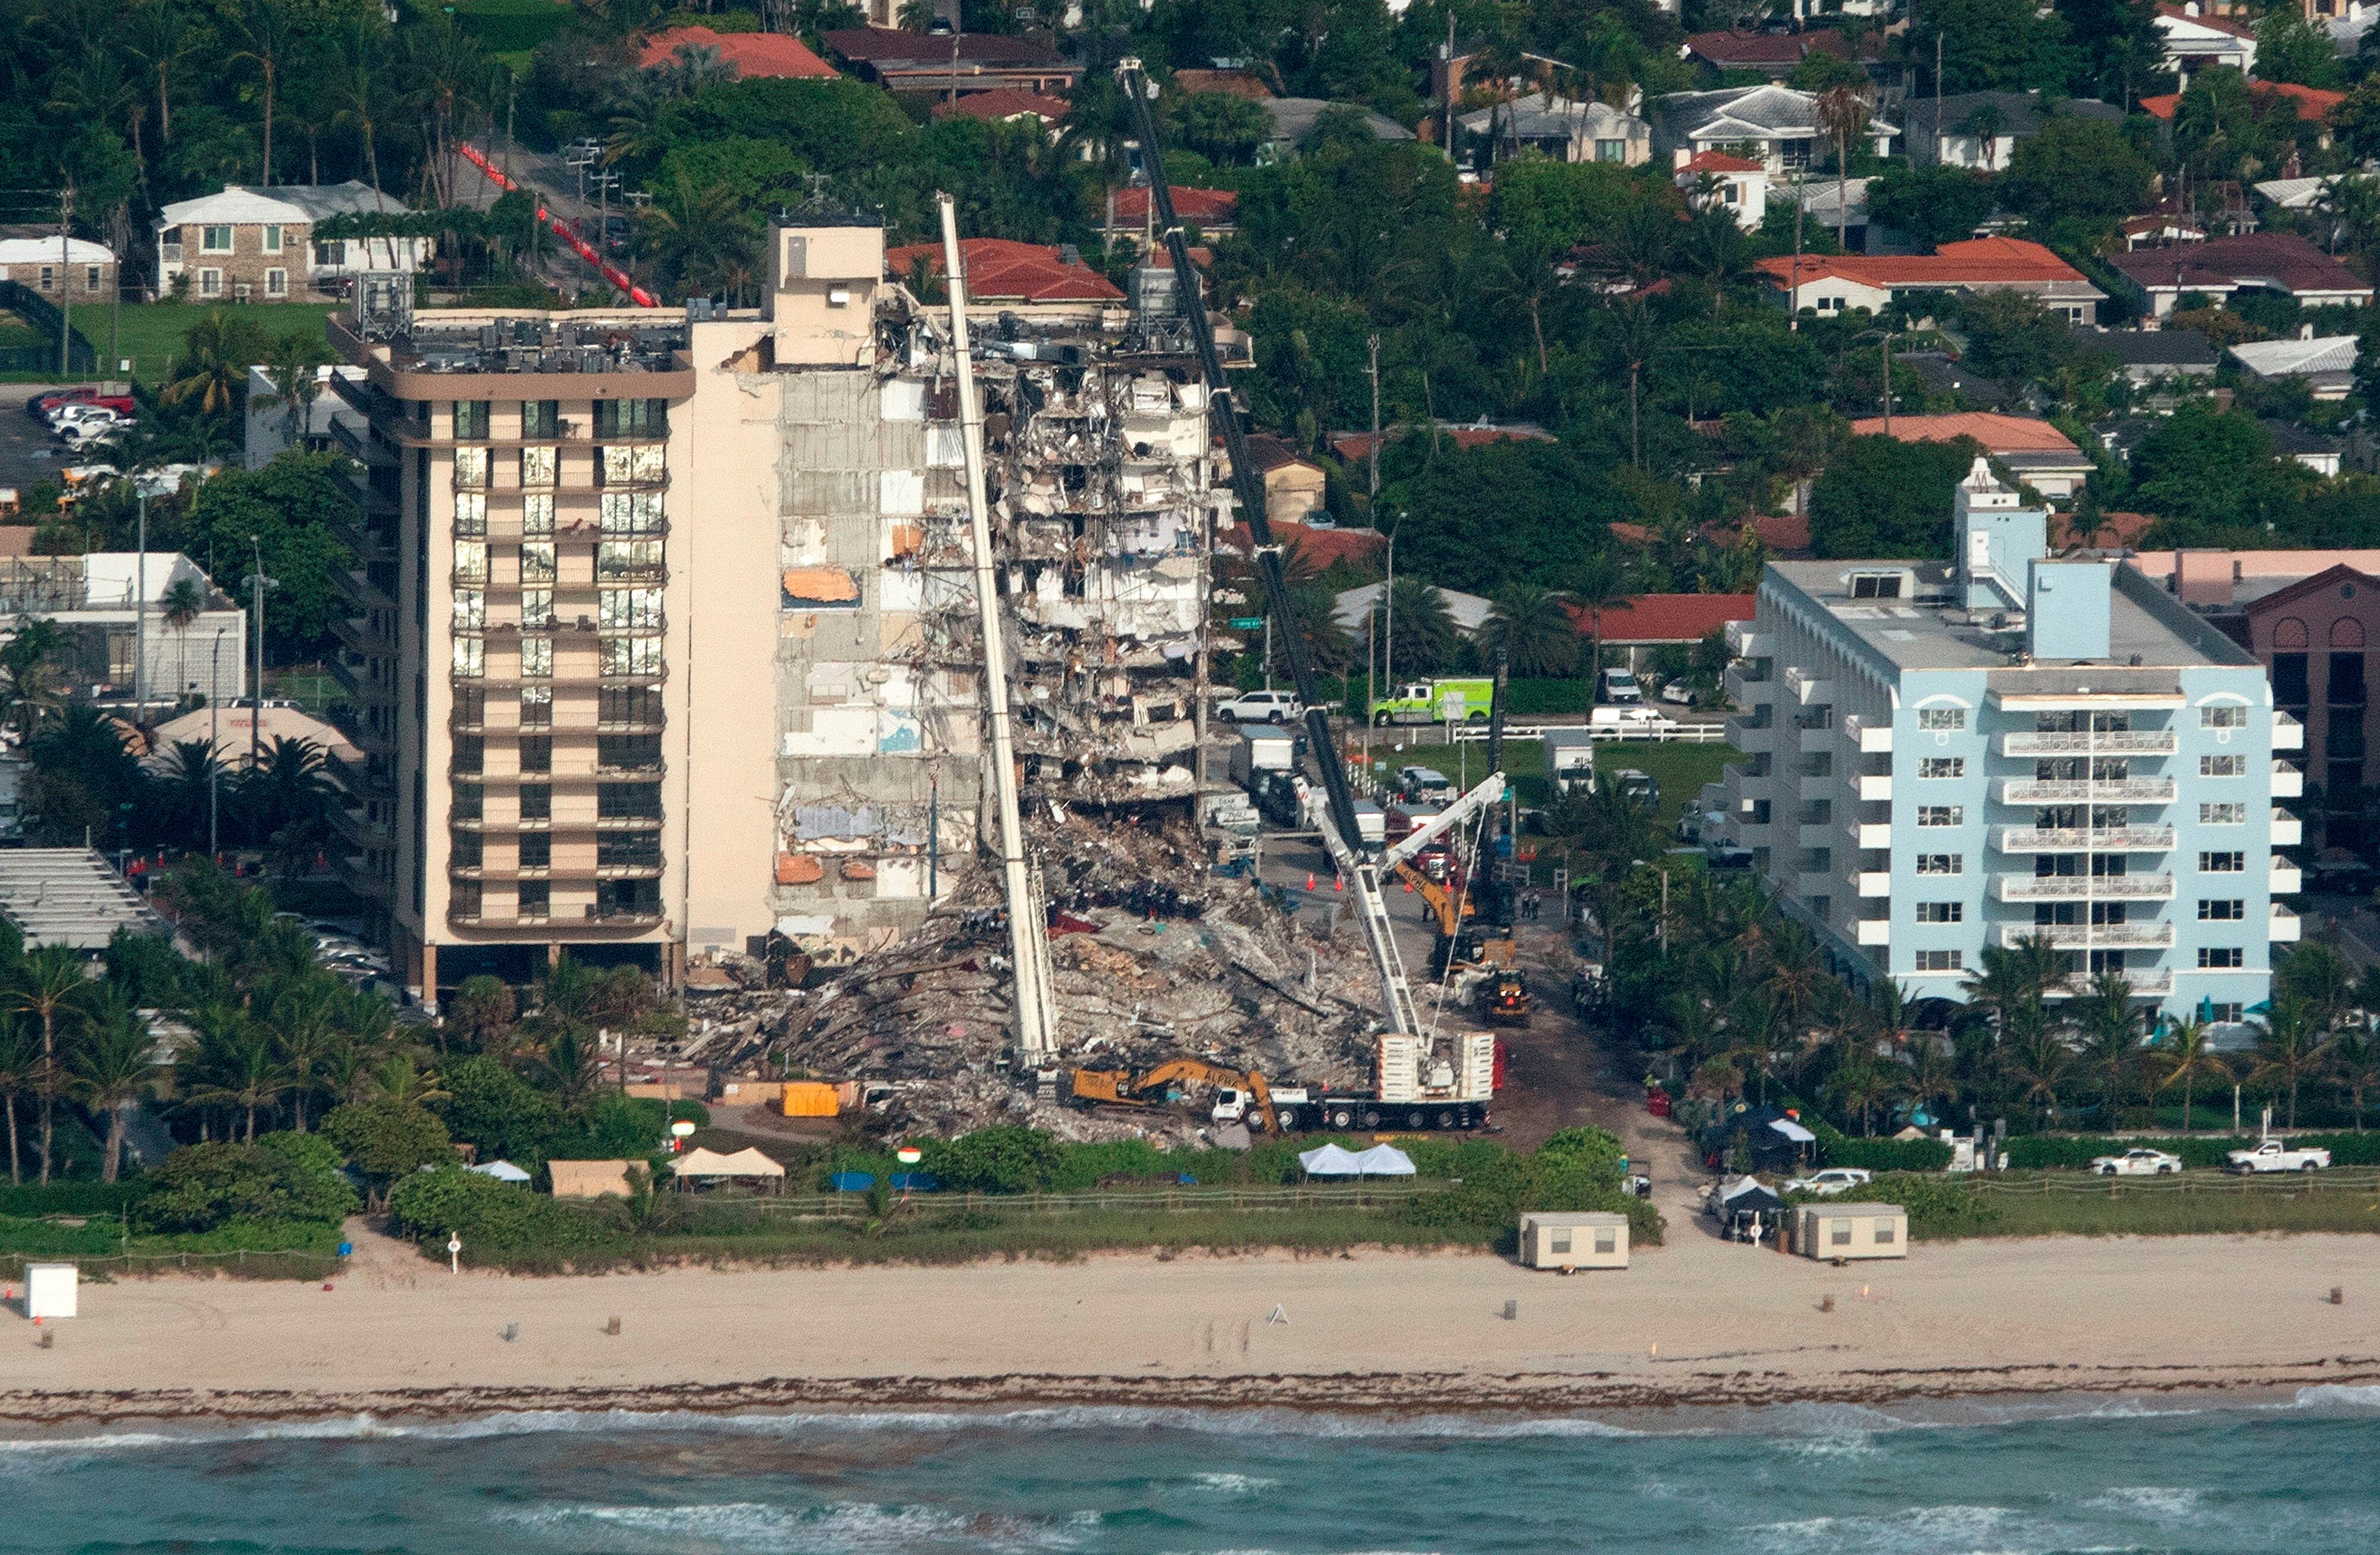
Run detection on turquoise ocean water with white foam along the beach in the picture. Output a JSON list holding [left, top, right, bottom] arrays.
[[0, 1388, 2380, 1555]]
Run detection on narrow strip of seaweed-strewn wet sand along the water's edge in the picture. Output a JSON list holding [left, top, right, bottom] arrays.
[[0, 1355, 2380, 1443]]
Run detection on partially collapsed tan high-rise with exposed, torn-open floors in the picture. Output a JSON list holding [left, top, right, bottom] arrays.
[[333, 219, 1228, 999]]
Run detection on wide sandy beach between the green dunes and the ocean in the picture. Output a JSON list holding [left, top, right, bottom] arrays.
[[0, 1219, 2380, 1424]]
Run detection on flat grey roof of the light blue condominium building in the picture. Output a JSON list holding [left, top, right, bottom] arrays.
[[1768, 561, 2254, 694]]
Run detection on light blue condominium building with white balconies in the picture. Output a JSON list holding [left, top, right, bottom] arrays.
[[1704, 459, 2304, 1023]]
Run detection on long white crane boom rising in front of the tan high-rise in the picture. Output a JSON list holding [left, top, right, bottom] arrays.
[[935, 193, 1057, 1068]]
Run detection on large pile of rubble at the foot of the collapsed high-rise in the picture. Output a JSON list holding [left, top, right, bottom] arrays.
[[712, 816, 1378, 1139]]
